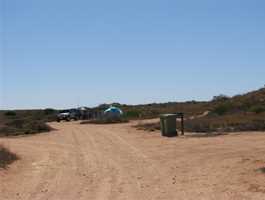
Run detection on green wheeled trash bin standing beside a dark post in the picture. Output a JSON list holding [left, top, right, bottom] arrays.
[[160, 114, 178, 137]]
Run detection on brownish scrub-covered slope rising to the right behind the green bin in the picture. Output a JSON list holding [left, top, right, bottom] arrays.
[[137, 88, 265, 133]]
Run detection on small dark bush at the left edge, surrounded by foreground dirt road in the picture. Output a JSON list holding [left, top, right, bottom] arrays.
[[0, 145, 19, 169]]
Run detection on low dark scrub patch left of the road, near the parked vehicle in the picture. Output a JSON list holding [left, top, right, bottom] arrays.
[[0, 109, 57, 136]]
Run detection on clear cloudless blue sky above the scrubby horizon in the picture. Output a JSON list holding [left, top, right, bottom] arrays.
[[0, 0, 265, 109]]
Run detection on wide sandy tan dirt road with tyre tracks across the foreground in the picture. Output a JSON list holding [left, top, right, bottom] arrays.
[[0, 122, 265, 200]]
